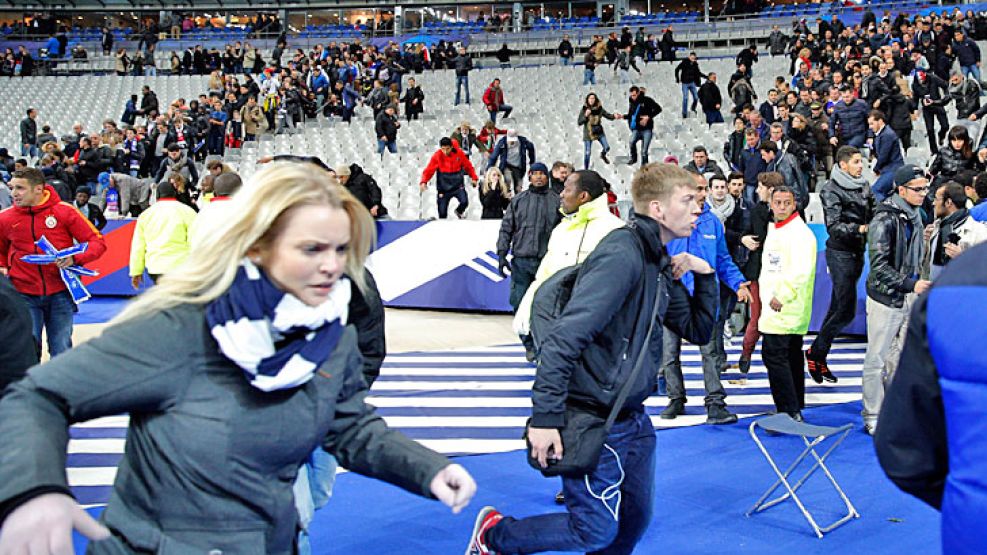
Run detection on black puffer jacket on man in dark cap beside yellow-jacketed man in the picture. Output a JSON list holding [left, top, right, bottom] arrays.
[[497, 185, 562, 259]]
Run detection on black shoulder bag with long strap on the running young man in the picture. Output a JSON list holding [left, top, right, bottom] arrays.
[[524, 264, 661, 477]]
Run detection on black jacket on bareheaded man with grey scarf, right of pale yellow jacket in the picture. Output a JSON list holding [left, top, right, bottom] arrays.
[[819, 179, 874, 255]]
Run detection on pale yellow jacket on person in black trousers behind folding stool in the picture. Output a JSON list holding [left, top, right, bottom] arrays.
[[757, 212, 816, 335]]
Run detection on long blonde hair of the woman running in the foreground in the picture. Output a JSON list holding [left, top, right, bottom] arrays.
[[113, 162, 376, 324]]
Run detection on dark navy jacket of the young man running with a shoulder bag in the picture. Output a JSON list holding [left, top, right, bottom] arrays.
[[531, 214, 719, 428]]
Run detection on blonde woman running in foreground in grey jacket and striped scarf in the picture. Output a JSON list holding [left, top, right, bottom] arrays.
[[0, 164, 476, 555]]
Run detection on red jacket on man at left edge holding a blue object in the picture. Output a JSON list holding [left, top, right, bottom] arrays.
[[0, 185, 106, 295]]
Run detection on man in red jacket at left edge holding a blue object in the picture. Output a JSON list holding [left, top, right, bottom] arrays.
[[0, 168, 106, 356]]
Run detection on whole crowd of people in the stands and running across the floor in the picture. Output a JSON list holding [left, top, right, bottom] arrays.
[[0, 6, 987, 555]]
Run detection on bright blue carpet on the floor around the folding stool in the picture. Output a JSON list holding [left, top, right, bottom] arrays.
[[76, 403, 940, 555]]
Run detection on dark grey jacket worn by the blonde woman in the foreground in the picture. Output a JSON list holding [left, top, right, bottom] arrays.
[[0, 305, 449, 555]]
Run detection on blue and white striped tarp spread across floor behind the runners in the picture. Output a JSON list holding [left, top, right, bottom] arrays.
[[67, 337, 866, 505]]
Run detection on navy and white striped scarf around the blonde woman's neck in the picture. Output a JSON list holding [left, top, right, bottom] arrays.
[[206, 259, 350, 391]]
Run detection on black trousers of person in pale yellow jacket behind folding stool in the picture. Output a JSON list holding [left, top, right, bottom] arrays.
[[761, 333, 805, 414]]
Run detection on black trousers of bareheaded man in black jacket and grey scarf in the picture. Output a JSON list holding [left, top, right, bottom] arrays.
[[811, 249, 864, 359]]
